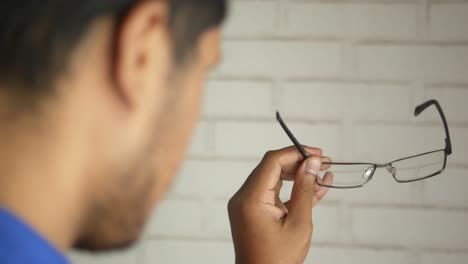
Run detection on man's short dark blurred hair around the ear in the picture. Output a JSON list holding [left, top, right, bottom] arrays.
[[0, 0, 227, 96]]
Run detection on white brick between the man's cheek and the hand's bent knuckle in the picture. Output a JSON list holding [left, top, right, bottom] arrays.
[[171, 160, 257, 200]]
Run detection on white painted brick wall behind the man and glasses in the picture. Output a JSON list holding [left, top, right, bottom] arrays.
[[72, 0, 468, 264]]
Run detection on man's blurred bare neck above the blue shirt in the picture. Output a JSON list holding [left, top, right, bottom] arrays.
[[0, 102, 88, 253]]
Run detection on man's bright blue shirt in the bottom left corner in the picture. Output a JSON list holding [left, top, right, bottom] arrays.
[[0, 207, 68, 264]]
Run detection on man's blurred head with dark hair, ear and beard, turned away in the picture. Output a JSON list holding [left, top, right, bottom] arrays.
[[0, 0, 227, 250]]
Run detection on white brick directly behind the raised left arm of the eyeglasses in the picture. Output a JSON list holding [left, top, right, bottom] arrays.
[[215, 122, 341, 159]]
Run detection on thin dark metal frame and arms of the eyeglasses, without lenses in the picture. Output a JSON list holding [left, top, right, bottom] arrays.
[[276, 99, 452, 189]]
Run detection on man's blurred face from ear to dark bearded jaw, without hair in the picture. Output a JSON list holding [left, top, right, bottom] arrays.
[[75, 1, 224, 250]]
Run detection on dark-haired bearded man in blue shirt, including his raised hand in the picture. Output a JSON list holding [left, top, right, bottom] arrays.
[[0, 0, 331, 264]]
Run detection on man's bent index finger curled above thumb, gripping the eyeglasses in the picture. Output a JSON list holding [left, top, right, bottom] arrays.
[[248, 146, 322, 190]]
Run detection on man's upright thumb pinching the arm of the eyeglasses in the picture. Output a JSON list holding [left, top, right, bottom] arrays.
[[287, 157, 322, 227]]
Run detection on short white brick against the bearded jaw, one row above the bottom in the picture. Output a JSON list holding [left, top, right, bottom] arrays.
[[146, 200, 202, 236]]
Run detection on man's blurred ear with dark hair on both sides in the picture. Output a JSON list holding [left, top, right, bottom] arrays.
[[114, 1, 171, 107]]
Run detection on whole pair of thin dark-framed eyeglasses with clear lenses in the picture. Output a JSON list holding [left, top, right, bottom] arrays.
[[276, 100, 452, 189]]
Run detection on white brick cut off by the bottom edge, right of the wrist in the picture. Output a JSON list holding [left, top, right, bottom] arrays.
[[305, 248, 408, 264]]
